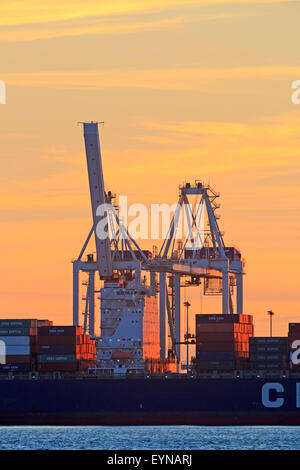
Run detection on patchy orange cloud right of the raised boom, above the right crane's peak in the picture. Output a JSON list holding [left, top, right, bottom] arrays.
[[129, 114, 300, 176]]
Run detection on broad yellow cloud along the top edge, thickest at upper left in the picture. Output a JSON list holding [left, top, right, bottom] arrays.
[[0, 0, 299, 42]]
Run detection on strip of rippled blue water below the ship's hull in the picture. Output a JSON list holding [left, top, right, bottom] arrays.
[[0, 426, 300, 450]]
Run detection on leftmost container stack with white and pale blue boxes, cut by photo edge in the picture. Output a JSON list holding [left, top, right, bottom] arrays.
[[0, 319, 51, 372]]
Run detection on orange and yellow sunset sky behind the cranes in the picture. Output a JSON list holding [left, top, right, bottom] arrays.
[[0, 0, 300, 335]]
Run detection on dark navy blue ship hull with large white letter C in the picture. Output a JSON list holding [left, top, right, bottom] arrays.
[[0, 378, 300, 425]]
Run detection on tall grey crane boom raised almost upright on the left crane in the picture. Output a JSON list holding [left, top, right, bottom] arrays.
[[83, 122, 112, 279]]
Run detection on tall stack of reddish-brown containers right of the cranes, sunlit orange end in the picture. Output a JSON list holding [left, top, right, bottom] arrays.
[[196, 314, 253, 371]]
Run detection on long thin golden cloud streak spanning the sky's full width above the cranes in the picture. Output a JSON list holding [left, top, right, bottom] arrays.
[[2, 65, 300, 93]]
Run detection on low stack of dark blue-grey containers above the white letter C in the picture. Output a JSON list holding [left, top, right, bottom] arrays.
[[249, 337, 287, 371]]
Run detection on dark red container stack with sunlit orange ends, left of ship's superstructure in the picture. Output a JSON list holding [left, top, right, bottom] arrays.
[[37, 326, 96, 372]]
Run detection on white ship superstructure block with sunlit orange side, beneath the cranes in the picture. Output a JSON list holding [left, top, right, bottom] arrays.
[[96, 280, 160, 374]]
